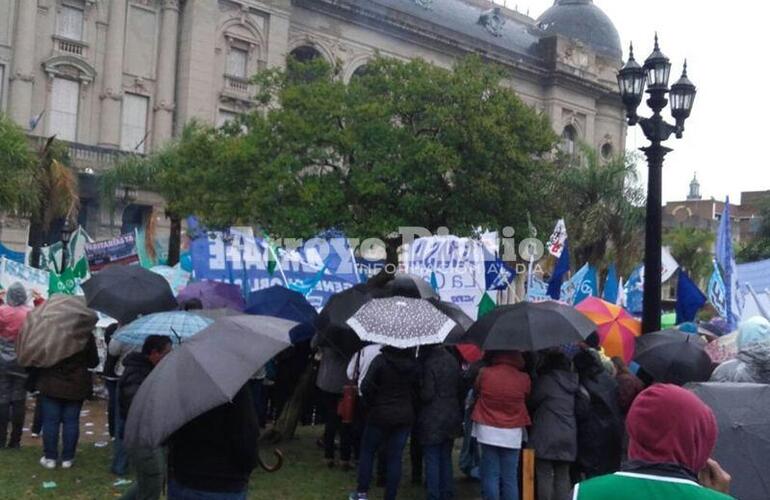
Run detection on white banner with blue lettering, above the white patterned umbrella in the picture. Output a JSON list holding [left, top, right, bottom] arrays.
[[405, 236, 486, 319]]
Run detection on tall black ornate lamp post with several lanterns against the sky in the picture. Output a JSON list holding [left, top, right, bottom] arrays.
[[618, 34, 696, 333]]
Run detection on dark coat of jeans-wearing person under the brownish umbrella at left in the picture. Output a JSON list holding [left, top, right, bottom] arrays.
[[37, 336, 99, 401]]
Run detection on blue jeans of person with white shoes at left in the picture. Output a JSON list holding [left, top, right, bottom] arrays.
[[40, 396, 83, 461]]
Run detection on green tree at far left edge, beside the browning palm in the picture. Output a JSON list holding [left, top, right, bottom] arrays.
[[0, 113, 35, 211]]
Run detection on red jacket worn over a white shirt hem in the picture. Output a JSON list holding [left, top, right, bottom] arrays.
[[471, 353, 532, 429]]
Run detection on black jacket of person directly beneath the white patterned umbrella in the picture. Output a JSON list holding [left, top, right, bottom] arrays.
[[361, 347, 420, 429]]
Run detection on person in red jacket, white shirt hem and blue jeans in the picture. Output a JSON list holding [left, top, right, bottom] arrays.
[[471, 351, 532, 500]]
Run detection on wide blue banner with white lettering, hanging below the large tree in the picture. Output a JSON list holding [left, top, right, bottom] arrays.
[[188, 218, 360, 309]]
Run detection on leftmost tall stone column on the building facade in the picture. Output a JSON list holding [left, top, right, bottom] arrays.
[[8, 1, 37, 130]]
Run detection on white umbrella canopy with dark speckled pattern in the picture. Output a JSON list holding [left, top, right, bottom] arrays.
[[348, 297, 456, 349]]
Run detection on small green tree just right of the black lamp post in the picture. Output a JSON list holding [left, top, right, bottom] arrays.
[[663, 228, 715, 284]]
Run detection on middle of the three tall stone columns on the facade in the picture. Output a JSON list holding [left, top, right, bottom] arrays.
[[99, 0, 126, 149]]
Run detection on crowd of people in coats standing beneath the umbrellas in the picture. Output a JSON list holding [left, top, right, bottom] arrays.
[[0, 276, 770, 500]]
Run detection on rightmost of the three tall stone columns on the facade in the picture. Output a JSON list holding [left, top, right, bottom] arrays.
[[152, 0, 179, 148]]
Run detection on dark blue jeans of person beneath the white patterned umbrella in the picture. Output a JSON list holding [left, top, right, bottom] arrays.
[[357, 424, 411, 500]]
